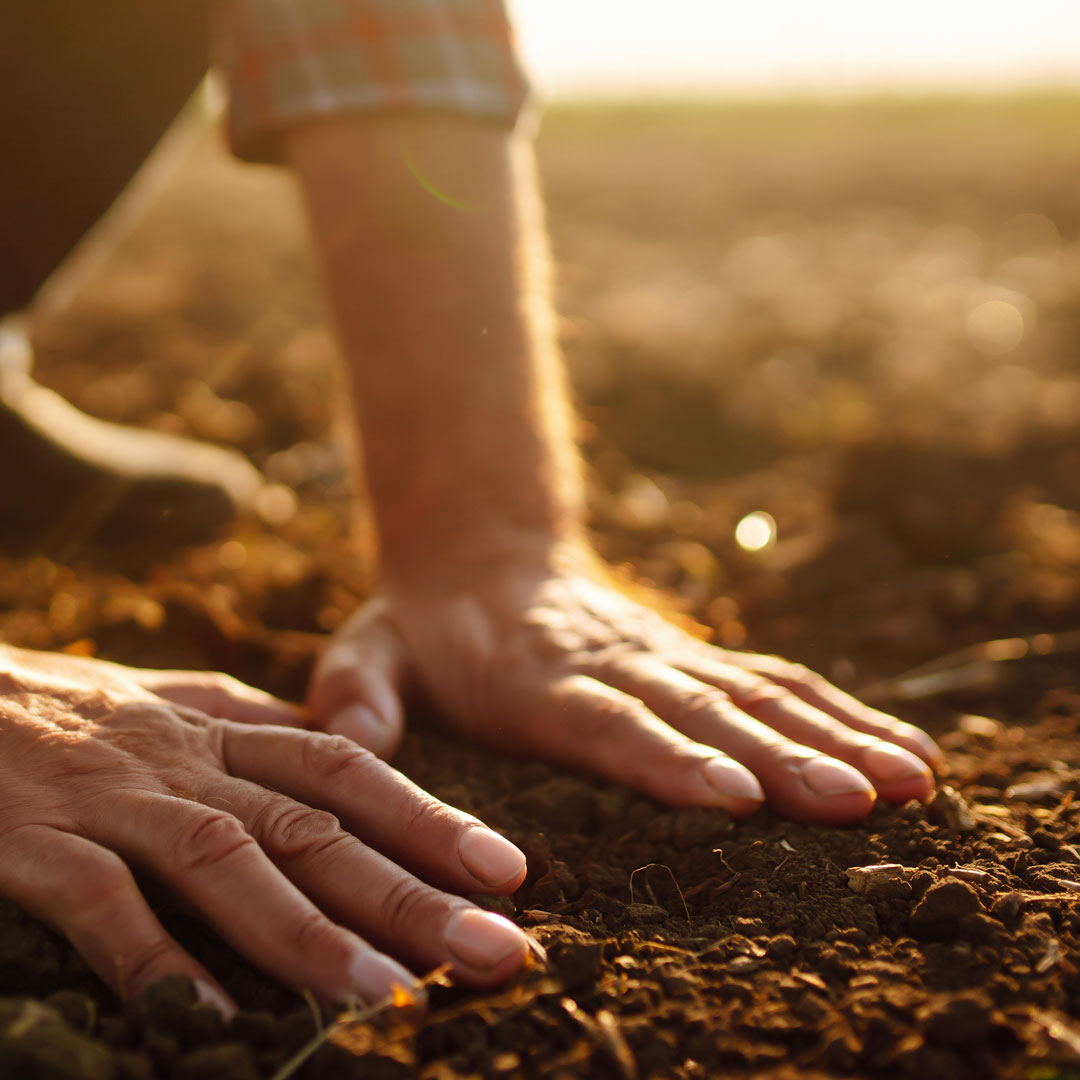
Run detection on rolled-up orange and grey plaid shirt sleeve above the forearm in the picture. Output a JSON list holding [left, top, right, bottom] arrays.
[[215, 0, 528, 161]]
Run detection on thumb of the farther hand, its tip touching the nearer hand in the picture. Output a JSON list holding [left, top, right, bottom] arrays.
[[308, 600, 408, 757]]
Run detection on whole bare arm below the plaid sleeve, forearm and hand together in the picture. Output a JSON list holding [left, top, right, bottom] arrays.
[[286, 117, 939, 842]]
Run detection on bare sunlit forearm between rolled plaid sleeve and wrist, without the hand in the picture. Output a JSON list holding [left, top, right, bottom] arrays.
[[287, 117, 581, 577]]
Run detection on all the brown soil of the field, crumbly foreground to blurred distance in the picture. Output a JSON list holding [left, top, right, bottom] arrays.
[[0, 100, 1080, 1080]]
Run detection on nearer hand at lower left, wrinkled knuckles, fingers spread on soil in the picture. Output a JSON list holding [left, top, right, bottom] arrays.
[[0, 646, 527, 1015]]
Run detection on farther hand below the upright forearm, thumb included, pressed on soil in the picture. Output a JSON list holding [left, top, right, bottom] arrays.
[[309, 545, 941, 824]]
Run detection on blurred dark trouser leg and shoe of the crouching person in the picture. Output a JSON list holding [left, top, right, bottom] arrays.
[[0, 0, 260, 558]]
